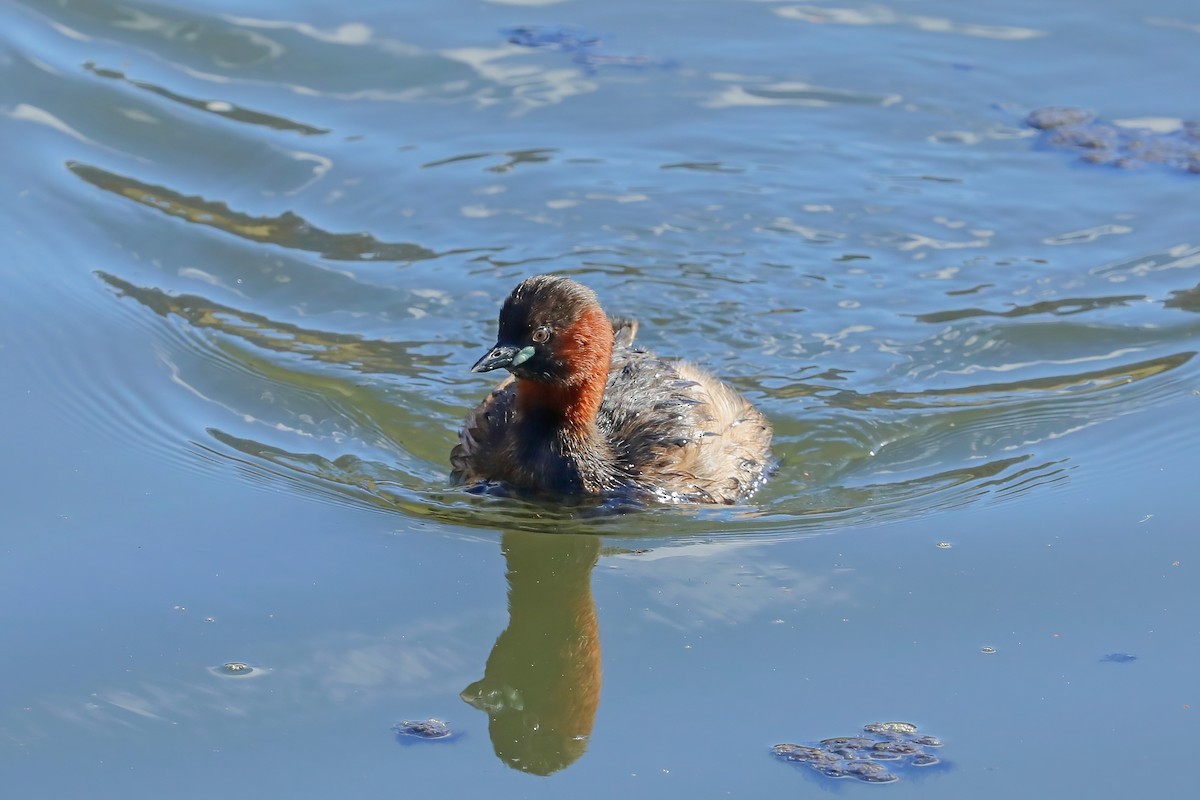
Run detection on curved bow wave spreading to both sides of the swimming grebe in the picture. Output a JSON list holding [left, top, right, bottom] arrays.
[[87, 261, 1195, 536]]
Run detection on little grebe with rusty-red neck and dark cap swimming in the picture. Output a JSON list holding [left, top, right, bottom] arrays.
[[450, 275, 772, 503]]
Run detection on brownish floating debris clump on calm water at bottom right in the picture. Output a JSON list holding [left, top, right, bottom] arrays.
[[772, 722, 942, 783]]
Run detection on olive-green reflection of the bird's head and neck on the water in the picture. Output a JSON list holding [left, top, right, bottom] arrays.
[[462, 533, 600, 775]]
